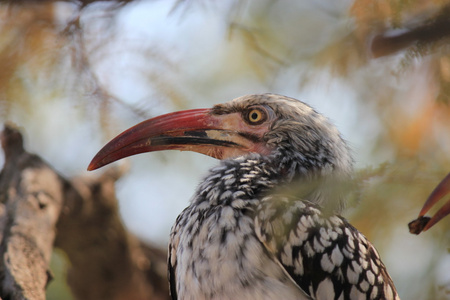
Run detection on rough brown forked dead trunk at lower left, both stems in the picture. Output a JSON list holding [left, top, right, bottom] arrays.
[[0, 125, 169, 299]]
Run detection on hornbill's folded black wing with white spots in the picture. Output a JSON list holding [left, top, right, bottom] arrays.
[[255, 196, 399, 299]]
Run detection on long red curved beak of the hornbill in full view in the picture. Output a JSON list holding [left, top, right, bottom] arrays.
[[88, 109, 269, 171]]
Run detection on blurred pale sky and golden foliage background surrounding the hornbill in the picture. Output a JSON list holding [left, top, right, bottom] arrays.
[[0, 0, 450, 299]]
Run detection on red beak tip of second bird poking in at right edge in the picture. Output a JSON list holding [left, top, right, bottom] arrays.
[[419, 173, 450, 231]]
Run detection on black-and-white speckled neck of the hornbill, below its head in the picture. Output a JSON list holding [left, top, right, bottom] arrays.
[[193, 153, 352, 212]]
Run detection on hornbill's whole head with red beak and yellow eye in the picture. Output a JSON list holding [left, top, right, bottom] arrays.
[[88, 94, 353, 209]]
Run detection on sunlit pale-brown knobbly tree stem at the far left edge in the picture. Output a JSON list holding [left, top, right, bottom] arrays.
[[0, 125, 63, 299]]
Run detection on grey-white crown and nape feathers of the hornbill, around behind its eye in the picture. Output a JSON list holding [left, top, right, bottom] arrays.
[[215, 94, 353, 212]]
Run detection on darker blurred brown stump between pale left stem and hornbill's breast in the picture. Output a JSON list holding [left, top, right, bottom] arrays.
[[55, 169, 168, 299]]
